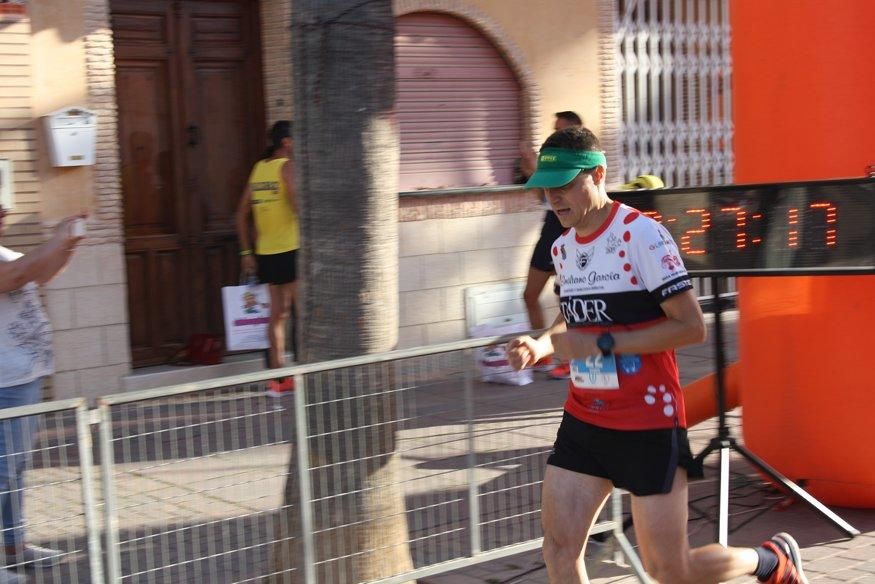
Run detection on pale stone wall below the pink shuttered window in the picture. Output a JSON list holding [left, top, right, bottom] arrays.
[[398, 187, 558, 348]]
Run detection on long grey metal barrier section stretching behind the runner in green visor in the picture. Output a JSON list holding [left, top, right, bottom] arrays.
[[0, 337, 646, 584]]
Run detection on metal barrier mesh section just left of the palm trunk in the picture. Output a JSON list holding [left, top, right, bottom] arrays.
[[99, 384, 291, 583]]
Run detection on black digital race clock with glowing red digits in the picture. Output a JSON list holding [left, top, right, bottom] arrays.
[[610, 179, 875, 276]]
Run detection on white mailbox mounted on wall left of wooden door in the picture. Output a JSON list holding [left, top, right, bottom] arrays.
[[43, 107, 97, 166]]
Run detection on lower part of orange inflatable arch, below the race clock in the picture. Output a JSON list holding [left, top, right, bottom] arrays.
[[738, 276, 875, 508]]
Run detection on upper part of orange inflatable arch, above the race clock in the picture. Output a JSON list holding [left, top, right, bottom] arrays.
[[730, 0, 875, 183]]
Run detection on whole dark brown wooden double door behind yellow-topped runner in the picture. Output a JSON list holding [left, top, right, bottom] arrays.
[[111, 0, 264, 366]]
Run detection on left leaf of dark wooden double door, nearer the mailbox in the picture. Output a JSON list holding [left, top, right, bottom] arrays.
[[112, 0, 188, 366]]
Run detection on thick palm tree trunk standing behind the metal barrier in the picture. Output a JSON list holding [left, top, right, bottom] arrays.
[[272, 0, 412, 584]]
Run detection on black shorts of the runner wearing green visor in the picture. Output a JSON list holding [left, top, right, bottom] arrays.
[[547, 412, 703, 497]]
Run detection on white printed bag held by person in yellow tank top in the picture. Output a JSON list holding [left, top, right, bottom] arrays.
[[222, 284, 270, 351]]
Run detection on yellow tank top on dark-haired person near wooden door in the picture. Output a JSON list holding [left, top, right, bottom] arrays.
[[249, 158, 300, 255]]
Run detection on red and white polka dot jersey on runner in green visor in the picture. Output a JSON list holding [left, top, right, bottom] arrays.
[[552, 201, 693, 430]]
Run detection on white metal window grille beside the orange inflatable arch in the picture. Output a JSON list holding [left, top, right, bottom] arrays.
[[602, 0, 733, 186]]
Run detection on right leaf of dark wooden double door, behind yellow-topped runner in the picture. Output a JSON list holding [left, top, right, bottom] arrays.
[[180, 1, 264, 332]]
